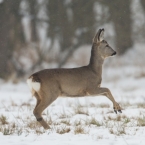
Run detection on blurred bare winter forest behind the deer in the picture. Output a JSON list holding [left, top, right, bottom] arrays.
[[0, 0, 145, 80]]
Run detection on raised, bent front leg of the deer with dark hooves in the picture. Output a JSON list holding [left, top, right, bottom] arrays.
[[89, 88, 122, 113]]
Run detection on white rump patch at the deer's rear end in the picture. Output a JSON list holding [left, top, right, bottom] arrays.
[[27, 78, 41, 92]]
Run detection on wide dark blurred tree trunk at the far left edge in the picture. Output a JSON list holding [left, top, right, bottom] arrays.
[[0, 0, 24, 79]]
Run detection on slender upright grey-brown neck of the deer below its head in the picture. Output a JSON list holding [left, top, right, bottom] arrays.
[[89, 47, 104, 75]]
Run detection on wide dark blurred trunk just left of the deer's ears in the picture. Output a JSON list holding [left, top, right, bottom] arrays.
[[72, 0, 95, 45]]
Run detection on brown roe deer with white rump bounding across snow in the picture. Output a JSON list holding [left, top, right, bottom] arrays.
[[27, 29, 121, 129]]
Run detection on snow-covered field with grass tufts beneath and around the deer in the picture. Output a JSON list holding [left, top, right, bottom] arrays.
[[0, 45, 145, 145]]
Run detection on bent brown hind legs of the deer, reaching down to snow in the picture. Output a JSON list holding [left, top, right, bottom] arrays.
[[33, 91, 57, 129]]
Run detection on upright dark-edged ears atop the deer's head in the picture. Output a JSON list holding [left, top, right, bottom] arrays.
[[93, 29, 104, 43]]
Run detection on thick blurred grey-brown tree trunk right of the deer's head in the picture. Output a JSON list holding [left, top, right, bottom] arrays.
[[103, 0, 133, 54]]
